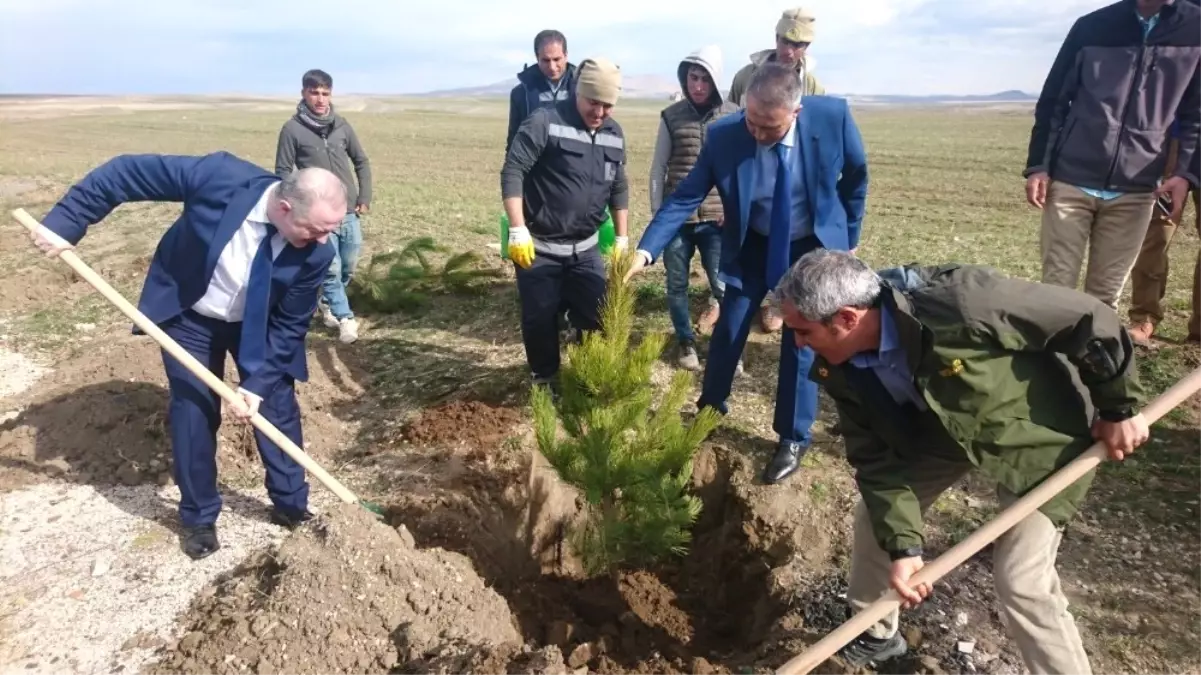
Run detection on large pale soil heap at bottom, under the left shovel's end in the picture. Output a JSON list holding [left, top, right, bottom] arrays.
[[147, 504, 520, 675]]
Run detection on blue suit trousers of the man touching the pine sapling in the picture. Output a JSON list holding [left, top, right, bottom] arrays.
[[697, 232, 820, 446]]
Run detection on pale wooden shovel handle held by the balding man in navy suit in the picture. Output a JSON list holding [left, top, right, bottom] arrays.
[[12, 209, 359, 503]]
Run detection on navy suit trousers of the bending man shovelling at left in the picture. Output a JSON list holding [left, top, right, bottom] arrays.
[[161, 310, 309, 527]]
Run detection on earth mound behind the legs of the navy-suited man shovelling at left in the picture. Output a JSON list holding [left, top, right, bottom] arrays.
[[0, 324, 362, 490]]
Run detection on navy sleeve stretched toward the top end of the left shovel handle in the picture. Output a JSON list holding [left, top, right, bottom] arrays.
[[42, 155, 205, 244]]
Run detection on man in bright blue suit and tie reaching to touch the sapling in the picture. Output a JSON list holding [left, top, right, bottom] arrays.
[[631, 64, 867, 483]]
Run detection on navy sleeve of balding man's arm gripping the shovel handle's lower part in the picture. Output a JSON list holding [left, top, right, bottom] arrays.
[[241, 254, 334, 399]]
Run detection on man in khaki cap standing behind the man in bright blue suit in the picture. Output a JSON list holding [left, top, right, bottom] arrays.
[[727, 7, 825, 333]]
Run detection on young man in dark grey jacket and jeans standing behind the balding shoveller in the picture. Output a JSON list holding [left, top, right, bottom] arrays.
[[275, 70, 371, 344]]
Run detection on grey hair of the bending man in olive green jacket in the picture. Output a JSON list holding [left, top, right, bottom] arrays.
[[772, 249, 883, 321]]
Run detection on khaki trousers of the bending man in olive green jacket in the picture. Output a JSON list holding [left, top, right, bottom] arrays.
[[847, 459, 1092, 675]]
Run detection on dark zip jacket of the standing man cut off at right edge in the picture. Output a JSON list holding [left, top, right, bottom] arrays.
[[1023, 0, 1201, 192]]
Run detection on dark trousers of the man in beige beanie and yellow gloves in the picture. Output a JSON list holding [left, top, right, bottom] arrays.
[[516, 246, 605, 380]]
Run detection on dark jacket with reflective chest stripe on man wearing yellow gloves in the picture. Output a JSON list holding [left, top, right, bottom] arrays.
[[501, 96, 629, 243]]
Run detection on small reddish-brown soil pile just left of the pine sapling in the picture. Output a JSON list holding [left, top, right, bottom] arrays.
[[400, 400, 522, 448]]
